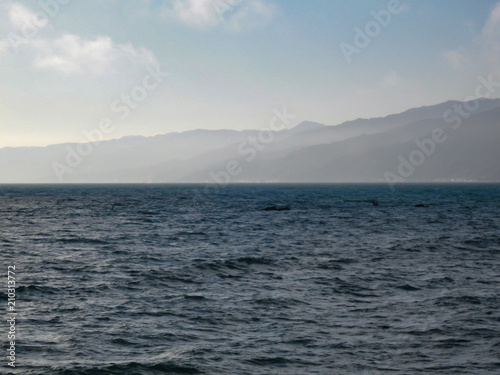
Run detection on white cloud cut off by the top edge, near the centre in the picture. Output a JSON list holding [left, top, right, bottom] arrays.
[[163, 0, 276, 31]]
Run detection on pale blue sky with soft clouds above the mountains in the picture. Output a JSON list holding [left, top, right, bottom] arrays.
[[0, 0, 500, 147]]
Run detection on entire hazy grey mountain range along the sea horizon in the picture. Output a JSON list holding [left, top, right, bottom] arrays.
[[0, 99, 500, 183]]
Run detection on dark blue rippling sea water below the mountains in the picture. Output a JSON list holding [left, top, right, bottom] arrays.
[[0, 185, 500, 375]]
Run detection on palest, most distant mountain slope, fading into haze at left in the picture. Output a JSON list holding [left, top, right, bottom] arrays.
[[0, 128, 308, 183]]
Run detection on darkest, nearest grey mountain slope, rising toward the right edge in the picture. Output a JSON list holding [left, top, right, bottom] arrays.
[[190, 108, 500, 182]]
